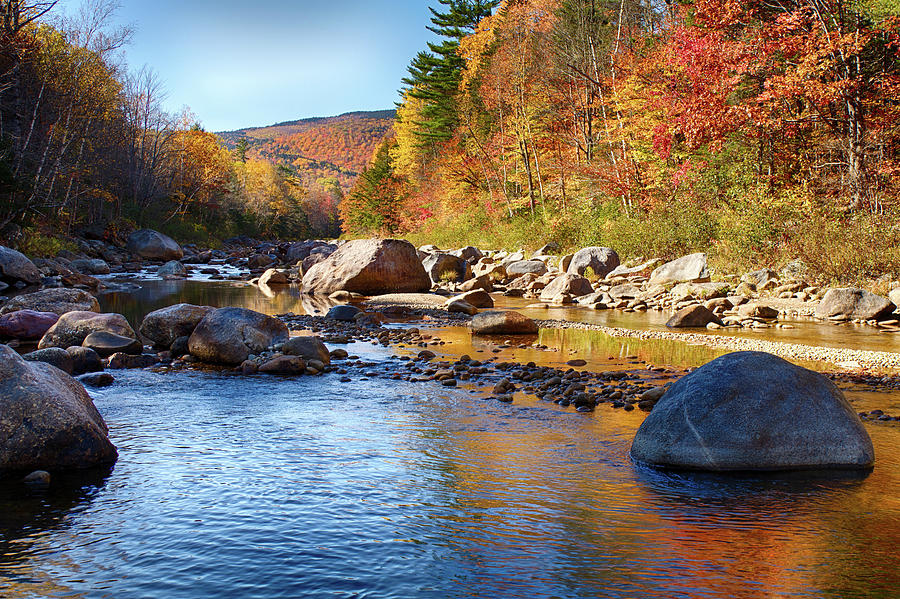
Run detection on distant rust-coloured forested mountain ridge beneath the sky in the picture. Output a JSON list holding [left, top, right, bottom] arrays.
[[217, 110, 396, 191]]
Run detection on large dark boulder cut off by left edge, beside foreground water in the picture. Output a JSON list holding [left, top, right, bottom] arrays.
[[0, 345, 118, 473]]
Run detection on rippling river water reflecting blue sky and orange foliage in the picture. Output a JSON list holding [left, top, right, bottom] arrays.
[[0, 281, 900, 598]]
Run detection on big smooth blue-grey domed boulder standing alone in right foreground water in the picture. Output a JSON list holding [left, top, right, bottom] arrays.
[[631, 352, 875, 471]]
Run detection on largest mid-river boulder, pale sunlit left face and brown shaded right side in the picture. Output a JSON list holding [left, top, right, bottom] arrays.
[[303, 239, 431, 295]]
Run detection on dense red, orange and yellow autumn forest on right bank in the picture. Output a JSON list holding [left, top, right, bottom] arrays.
[[341, 0, 900, 279]]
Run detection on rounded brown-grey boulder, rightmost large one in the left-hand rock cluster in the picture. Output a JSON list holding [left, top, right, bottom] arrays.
[[188, 308, 289, 365]]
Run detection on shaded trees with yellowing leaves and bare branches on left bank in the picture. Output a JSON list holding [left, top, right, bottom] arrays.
[[0, 0, 355, 248]]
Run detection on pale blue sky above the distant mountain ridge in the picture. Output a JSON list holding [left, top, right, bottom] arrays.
[[54, 0, 438, 131]]
